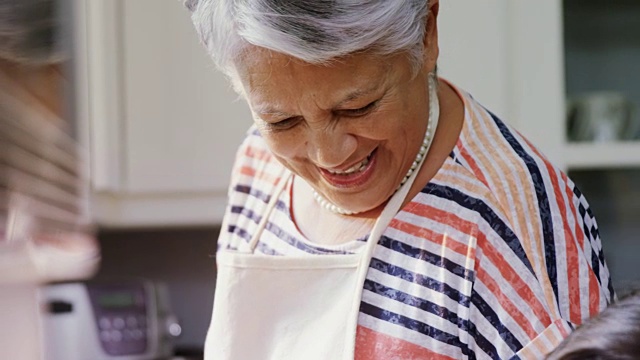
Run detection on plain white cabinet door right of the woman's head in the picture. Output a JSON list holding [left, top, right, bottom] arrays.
[[438, 0, 566, 166]]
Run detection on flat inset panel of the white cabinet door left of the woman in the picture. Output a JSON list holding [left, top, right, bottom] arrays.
[[121, 0, 251, 193]]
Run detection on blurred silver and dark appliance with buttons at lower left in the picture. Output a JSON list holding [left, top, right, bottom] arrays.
[[41, 280, 181, 360]]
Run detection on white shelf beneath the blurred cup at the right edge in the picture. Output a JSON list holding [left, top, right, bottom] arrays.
[[564, 141, 640, 170]]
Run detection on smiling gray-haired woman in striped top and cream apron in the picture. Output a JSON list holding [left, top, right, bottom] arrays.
[[187, 0, 613, 359]]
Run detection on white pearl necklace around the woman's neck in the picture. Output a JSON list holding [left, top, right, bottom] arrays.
[[313, 74, 439, 215]]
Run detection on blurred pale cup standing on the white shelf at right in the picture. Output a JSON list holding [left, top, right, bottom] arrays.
[[567, 91, 640, 142]]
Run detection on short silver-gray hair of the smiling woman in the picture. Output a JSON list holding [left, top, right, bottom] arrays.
[[185, 0, 428, 80]]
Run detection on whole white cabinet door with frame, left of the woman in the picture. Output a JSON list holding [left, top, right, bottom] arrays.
[[77, 0, 251, 226]]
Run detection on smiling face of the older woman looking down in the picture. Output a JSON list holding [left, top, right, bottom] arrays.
[[237, 48, 429, 212]]
